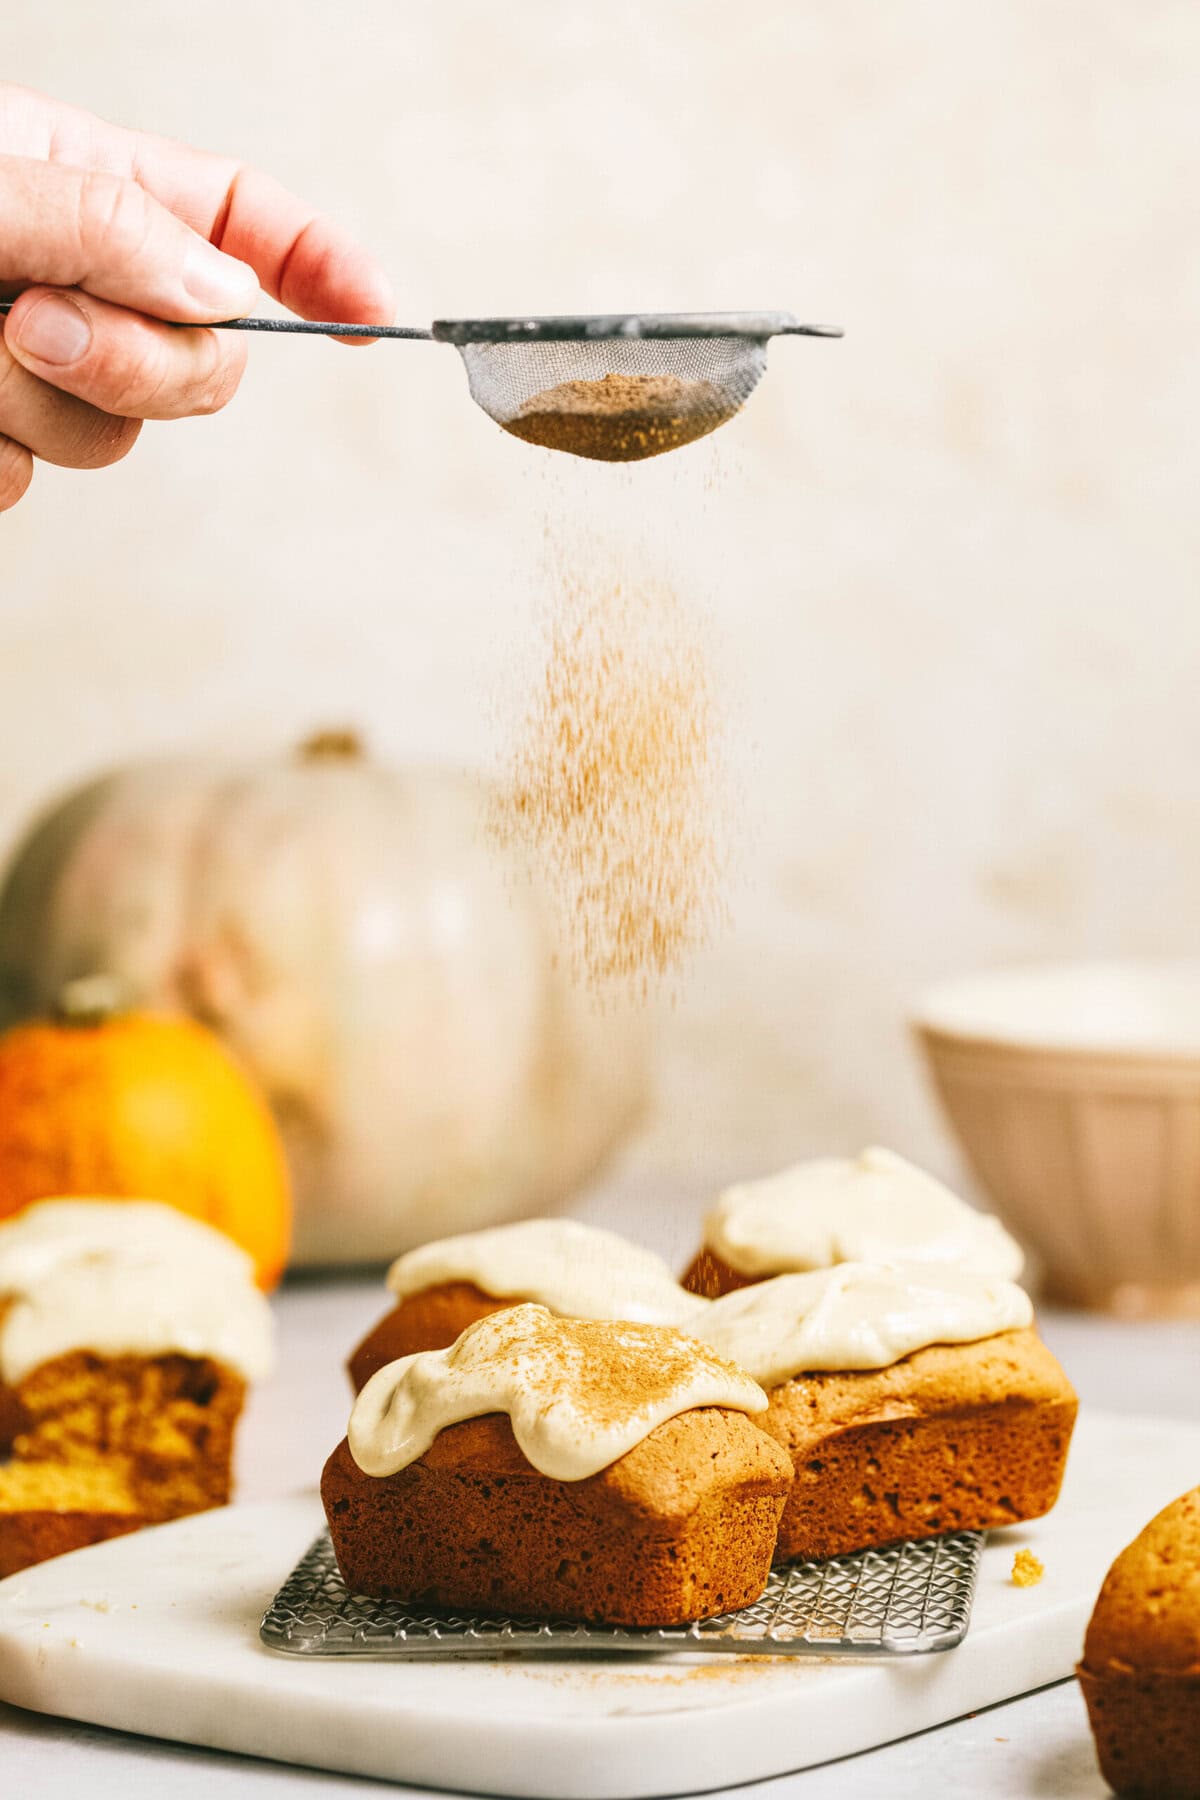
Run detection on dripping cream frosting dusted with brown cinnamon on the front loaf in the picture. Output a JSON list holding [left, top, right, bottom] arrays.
[[347, 1305, 766, 1481]]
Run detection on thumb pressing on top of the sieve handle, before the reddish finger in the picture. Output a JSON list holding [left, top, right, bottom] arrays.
[[0, 157, 259, 324]]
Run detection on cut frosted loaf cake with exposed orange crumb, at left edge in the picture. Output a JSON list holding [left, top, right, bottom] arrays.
[[0, 1201, 272, 1575]]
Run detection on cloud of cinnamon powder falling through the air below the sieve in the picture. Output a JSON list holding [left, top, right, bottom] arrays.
[[493, 558, 725, 992]]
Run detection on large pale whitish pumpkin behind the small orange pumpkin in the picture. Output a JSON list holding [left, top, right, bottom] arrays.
[[0, 738, 646, 1264]]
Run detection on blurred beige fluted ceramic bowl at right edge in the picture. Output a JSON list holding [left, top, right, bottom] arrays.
[[912, 961, 1200, 1318]]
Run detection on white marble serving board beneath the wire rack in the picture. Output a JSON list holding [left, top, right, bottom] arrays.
[[0, 1413, 1200, 1800]]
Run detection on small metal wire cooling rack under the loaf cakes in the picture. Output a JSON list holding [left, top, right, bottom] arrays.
[[259, 1532, 984, 1658]]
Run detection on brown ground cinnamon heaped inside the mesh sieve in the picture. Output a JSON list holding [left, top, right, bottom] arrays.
[[500, 374, 738, 463]]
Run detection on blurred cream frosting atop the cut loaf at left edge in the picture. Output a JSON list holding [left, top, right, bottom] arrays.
[[0, 1199, 272, 1386]]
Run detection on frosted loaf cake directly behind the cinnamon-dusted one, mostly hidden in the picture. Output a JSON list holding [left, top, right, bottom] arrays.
[[349, 1219, 698, 1391]]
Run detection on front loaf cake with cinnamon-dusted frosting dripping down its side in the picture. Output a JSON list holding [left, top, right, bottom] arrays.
[[320, 1305, 792, 1625]]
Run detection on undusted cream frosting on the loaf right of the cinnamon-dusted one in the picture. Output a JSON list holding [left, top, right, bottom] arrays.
[[693, 1262, 1033, 1388]]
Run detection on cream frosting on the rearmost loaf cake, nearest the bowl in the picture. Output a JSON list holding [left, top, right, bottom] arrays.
[[705, 1148, 1024, 1280]]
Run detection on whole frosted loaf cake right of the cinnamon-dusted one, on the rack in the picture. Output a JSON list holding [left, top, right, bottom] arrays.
[[693, 1262, 1076, 1561]]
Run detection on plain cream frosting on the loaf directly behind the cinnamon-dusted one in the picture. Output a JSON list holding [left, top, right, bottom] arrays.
[[387, 1219, 705, 1325]]
